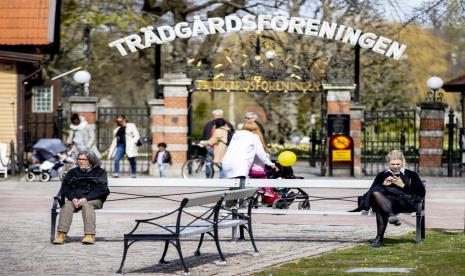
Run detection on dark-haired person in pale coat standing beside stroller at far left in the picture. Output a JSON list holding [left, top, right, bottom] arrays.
[[66, 113, 100, 158]]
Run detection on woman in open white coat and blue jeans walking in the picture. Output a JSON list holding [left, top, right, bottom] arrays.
[[108, 115, 140, 177]]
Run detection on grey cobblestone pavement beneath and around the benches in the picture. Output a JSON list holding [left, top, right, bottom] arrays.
[[0, 170, 465, 275]]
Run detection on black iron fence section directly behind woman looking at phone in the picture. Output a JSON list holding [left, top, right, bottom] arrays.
[[362, 109, 419, 175]]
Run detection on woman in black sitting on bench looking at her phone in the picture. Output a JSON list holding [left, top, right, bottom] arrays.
[[365, 150, 426, 247]]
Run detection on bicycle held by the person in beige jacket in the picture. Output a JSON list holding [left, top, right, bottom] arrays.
[[181, 144, 221, 179]]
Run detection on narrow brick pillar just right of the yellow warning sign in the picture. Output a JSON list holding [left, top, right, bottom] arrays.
[[350, 104, 365, 177]]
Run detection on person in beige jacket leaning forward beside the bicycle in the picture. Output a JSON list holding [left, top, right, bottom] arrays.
[[200, 118, 234, 178]]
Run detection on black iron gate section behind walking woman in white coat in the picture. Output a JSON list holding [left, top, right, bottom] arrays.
[[97, 107, 152, 175]]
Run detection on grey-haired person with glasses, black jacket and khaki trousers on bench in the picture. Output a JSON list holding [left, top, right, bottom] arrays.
[[53, 150, 110, 244]]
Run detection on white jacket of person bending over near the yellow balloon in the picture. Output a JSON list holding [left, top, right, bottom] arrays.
[[222, 130, 273, 178]]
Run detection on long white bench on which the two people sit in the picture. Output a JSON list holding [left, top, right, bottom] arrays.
[[50, 177, 425, 243]]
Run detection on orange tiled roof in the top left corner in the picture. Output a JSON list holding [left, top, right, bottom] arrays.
[[0, 0, 57, 45]]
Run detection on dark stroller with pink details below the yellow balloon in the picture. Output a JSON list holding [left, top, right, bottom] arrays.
[[255, 160, 310, 210]]
